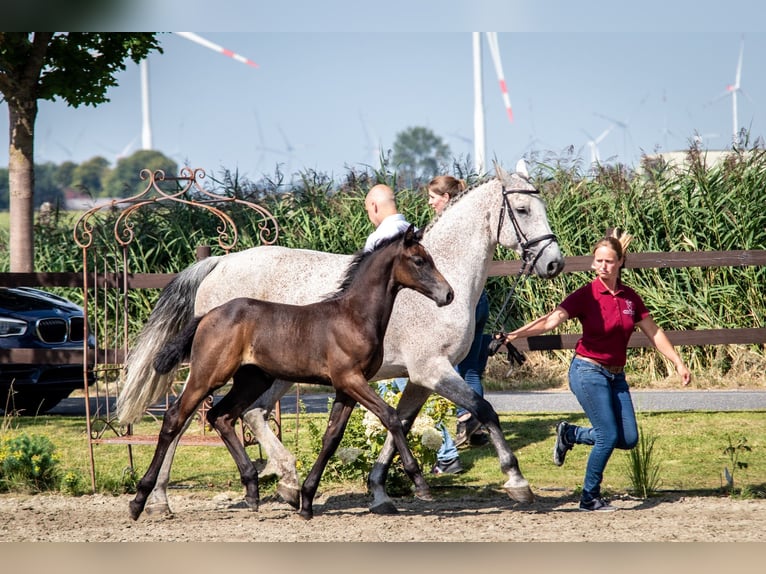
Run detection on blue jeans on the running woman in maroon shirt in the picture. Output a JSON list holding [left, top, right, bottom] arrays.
[[566, 357, 638, 502]]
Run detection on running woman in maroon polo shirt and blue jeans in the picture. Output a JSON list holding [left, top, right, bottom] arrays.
[[506, 229, 691, 512]]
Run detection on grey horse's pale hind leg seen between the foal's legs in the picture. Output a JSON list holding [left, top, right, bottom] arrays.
[[243, 379, 300, 509]]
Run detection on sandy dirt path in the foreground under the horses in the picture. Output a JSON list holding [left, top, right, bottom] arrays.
[[0, 491, 766, 542]]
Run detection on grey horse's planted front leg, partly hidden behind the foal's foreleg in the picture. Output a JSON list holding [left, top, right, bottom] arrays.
[[367, 384, 431, 514]]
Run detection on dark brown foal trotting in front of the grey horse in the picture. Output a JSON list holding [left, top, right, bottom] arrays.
[[130, 226, 454, 520]]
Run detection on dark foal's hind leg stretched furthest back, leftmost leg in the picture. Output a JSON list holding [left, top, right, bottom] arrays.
[[129, 386, 213, 520]]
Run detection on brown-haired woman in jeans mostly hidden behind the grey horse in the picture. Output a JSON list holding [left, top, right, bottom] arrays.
[[428, 175, 492, 448]]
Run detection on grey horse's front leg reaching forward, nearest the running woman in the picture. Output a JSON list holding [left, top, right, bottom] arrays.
[[432, 367, 534, 503]]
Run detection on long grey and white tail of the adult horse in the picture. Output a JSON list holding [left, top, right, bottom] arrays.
[[116, 256, 220, 424]]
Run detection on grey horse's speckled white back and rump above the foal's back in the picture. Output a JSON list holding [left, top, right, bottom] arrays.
[[195, 245, 351, 315]]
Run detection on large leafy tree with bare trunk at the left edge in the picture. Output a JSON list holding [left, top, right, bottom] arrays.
[[0, 32, 162, 272]]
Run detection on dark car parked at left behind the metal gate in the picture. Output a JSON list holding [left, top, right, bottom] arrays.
[[0, 287, 95, 415]]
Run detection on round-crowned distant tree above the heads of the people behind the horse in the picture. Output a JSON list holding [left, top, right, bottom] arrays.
[[393, 127, 450, 185]]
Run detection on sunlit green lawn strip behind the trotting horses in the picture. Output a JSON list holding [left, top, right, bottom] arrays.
[[3, 412, 766, 497]]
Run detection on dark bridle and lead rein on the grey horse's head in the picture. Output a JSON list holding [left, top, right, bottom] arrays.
[[490, 185, 556, 365]]
